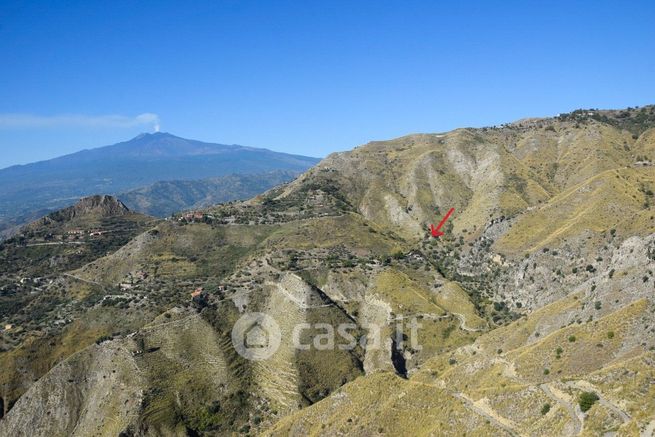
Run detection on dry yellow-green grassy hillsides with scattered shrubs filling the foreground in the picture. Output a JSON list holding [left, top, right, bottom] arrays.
[[0, 106, 655, 436]]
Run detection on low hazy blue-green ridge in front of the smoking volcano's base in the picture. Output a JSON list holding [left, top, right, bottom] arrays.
[[118, 170, 299, 217]]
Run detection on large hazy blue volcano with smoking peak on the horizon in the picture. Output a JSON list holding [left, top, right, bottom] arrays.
[[0, 132, 319, 232]]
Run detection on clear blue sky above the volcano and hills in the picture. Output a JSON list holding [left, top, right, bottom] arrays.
[[0, 0, 655, 168]]
